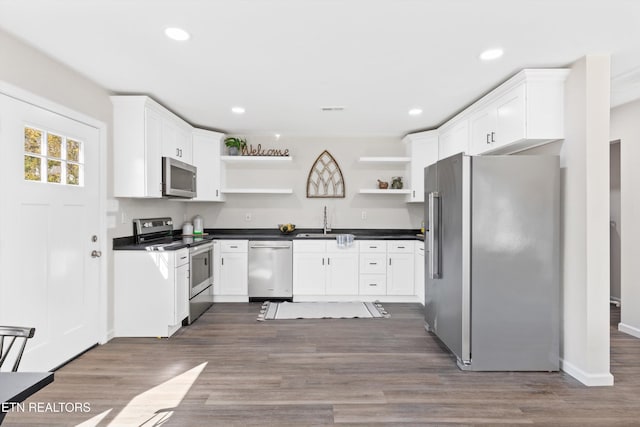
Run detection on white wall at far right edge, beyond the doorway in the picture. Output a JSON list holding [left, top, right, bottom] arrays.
[[610, 97, 640, 338]]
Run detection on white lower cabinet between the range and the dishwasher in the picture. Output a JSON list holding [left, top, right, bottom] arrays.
[[213, 240, 249, 302]]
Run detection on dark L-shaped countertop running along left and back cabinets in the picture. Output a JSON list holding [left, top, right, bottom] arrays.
[[113, 228, 424, 251]]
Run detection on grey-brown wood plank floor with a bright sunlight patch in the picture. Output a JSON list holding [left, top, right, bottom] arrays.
[[3, 303, 640, 426]]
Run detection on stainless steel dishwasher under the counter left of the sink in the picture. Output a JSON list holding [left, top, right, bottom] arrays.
[[249, 240, 293, 301]]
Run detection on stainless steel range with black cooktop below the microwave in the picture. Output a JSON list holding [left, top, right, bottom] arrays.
[[133, 217, 213, 324]]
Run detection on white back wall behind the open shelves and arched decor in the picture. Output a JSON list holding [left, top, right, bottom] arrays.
[[187, 136, 423, 229]]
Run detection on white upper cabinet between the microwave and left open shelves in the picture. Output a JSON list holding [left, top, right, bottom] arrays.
[[191, 129, 225, 202]]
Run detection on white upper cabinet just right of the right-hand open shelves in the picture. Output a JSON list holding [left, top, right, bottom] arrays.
[[402, 131, 438, 202]]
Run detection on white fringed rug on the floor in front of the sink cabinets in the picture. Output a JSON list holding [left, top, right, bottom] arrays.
[[258, 301, 389, 321]]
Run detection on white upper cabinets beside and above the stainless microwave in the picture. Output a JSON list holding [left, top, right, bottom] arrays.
[[111, 96, 193, 198]]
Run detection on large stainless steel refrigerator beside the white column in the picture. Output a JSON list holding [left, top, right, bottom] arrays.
[[424, 154, 560, 371]]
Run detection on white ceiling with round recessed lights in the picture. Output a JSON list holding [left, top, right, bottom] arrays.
[[0, 0, 640, 136]]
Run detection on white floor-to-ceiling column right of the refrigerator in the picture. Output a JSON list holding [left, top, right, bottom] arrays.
[[560, 55, 613, 386]]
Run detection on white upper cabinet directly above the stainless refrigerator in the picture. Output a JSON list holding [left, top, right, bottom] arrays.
[[469, 69, 568, 155]]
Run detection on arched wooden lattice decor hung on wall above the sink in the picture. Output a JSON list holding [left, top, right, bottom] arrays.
[[307, 150, 345, 198]]
